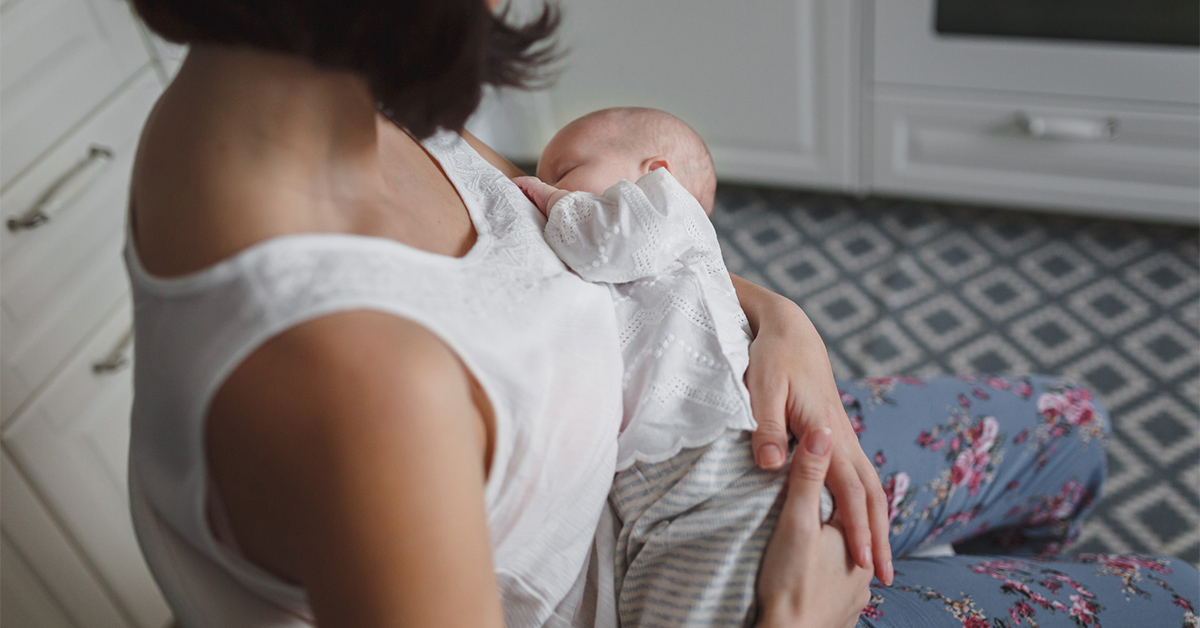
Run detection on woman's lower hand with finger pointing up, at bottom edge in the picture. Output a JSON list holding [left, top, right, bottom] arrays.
[[757, 427, 871, 628]]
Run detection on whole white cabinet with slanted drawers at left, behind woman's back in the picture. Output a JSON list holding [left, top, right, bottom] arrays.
[[0, 0, 172, 628]]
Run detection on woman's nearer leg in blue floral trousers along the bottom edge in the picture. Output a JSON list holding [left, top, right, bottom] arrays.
[[859, 555, 1200, 628]]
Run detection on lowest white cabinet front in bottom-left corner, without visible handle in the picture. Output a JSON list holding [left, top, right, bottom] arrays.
[[0, 451, 130, 628]]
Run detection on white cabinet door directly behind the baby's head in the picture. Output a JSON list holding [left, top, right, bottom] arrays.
[[540, 0, 859, 189]]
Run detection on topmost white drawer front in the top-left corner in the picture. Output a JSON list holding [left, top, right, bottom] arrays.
[[0, 0, 150, 189]]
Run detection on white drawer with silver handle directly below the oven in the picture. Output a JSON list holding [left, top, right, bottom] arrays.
[[870, 89, 1200, 223]]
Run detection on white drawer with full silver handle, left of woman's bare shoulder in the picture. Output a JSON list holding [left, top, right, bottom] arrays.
[[0, 68, 161, 419]]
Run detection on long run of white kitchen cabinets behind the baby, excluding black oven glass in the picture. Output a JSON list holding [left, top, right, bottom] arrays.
[[473, 0, 1200, 225]]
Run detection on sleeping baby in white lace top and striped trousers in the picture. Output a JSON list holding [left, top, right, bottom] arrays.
[[515, 108, 833, 626]]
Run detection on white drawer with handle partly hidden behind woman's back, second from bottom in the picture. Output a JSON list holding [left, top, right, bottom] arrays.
[[2, 298, 170, 628]]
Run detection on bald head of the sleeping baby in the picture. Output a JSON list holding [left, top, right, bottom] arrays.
[[538, 107, 716, 214]]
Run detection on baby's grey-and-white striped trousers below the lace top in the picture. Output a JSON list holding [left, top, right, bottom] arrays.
[[610, 432, 787, 628]]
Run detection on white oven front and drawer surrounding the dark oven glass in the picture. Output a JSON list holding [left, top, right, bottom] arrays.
[[864, 0, 1200, 225]]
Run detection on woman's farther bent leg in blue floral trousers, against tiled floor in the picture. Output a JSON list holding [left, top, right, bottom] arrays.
[[839, 376, 1109, 556]]
